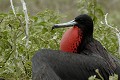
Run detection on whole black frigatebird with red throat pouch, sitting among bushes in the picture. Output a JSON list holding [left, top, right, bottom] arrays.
[[32, 14, 120, 80]]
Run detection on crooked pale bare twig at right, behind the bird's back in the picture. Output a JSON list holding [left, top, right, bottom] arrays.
[[105, 13, 120, 55]]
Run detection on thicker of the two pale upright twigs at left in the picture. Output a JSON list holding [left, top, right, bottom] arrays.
[[21, 0, 29, 47]]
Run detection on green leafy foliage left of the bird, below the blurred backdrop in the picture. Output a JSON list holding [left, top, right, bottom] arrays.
[[0, 10, 63, 80]]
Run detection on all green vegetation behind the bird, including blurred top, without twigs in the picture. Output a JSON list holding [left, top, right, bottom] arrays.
[[0, 0, 120, 80]]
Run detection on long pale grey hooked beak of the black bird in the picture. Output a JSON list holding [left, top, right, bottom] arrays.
[[52, 20, 77, 30]]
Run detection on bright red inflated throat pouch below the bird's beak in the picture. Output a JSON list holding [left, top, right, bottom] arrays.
[[60, 26, 82, 52]]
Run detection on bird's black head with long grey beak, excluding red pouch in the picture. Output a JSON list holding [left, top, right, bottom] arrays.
[[52, 14, 93, 36]]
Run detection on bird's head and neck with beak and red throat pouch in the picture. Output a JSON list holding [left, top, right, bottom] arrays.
[[52, 14, 93, 53]]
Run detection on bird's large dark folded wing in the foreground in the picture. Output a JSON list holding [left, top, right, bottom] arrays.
[[32, 49, 113, 80]]
